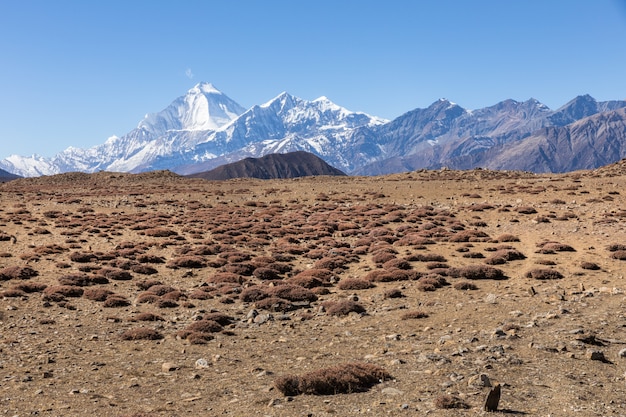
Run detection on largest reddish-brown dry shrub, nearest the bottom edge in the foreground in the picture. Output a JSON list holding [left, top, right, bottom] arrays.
[[274, 362, 391, 396]]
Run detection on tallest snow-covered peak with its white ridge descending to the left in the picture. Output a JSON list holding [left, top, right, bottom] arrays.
[[0, 83, 245, 176]]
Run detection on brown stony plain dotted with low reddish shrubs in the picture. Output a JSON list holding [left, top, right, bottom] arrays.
[[0, 162, 626, 417]]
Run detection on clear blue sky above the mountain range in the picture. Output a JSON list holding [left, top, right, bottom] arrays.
[[0, 0, 626, 158]]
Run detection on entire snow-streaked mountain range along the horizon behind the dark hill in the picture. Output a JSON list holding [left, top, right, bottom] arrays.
[[0, 83, 626, 176]]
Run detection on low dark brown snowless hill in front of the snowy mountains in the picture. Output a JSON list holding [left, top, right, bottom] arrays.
[[189, 151, 346, 180]]
